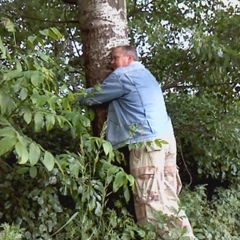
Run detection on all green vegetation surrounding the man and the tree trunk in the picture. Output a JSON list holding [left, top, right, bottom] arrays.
[[0, 0, 240, 240]]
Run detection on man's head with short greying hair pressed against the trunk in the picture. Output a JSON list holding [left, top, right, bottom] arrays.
[[111, 45, 138, 69]]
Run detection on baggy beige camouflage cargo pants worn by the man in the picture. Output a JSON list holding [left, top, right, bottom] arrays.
[[130, 136, 192, 233]]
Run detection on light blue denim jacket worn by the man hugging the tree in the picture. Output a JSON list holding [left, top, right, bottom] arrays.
[[80, 62, 173, 148]]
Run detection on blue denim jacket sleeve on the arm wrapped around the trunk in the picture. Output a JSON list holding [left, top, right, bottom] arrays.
[[79, 73, 124, 106]]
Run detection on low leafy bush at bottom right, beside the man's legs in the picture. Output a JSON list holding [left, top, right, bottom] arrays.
[[181, 184, 240, 240]]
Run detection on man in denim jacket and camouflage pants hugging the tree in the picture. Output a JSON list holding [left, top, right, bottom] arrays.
[[80, 45, 194, 238]]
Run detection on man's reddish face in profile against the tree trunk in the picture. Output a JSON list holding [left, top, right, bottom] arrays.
[[111, 48, 132, 70]]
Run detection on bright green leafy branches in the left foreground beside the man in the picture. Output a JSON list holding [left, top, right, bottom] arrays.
[[0, 17, 133, 239]]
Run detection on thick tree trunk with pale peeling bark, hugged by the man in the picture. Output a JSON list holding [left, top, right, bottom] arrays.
[[77, 0, 129, 135]]
